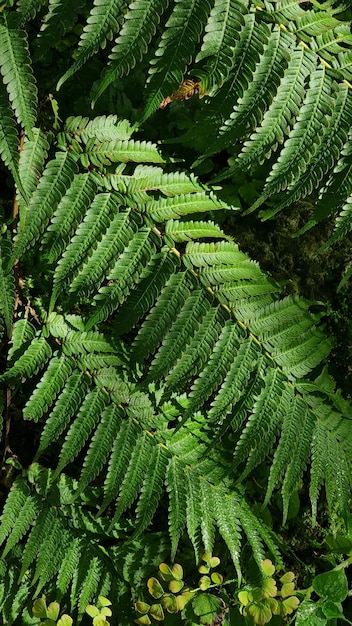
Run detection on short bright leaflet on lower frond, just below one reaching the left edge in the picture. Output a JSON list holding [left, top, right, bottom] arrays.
[[23, 357, 72, 421]]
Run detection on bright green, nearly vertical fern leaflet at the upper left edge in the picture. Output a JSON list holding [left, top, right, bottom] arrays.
[[0, 16, 38, 133]]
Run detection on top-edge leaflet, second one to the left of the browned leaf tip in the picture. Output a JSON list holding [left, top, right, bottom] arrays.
[[94, 0, 168, 102]]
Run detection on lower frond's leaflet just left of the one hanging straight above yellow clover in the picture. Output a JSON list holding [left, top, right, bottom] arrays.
[[134, 445, 169, 538]]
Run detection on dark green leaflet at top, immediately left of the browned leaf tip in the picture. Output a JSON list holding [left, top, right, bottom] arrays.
[[143, 0, 210, 119]]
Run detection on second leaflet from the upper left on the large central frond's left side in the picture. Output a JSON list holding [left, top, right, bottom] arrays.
[[42, 174, 97, 263]]
